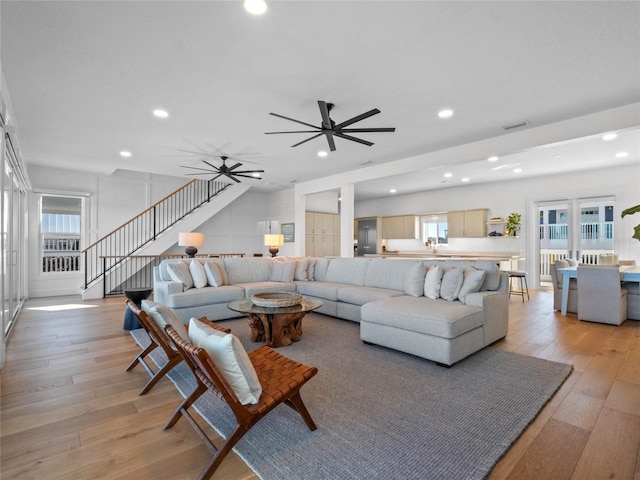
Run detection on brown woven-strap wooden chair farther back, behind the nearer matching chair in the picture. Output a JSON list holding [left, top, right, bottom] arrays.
[[126, 300, 231, 395]]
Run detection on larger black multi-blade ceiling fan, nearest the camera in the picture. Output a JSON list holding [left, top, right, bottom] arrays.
[[265, 100, 396, 152]]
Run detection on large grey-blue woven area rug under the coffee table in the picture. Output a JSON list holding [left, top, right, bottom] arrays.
[[132, 314, 572, 480]]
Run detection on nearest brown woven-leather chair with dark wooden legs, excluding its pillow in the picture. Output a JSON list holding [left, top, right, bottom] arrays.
[[164, 325, 318, 480]]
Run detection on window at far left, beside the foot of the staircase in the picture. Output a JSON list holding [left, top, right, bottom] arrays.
[[40, 195, 82, 273]]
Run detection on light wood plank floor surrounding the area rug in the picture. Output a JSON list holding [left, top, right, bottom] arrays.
[[0, 292, 640, 480]]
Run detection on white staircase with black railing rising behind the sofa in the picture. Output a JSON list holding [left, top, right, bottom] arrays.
[[81, 180, 251, 299]]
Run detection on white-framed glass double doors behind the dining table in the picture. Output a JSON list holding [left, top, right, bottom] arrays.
[[536, 197, 615, 287]]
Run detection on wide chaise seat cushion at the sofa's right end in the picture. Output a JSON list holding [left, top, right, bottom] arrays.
[[361, 296, 484, 338]]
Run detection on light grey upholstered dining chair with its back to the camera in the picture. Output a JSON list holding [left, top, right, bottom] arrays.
[[578, 265, 627, 325]]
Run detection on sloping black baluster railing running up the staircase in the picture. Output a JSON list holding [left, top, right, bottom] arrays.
[[81, 179, 230, 289]]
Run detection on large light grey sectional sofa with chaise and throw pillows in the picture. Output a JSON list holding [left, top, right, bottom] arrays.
[[154, 257, 509, 365]]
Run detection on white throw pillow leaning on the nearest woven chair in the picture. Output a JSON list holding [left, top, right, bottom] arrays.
[[189, 318, 262, 405]]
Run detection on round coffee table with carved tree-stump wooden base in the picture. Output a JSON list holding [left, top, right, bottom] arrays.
[[229, 298, 322, 348]]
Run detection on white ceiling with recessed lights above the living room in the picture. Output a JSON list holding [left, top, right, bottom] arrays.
[[0, 0, 640, 200]]
